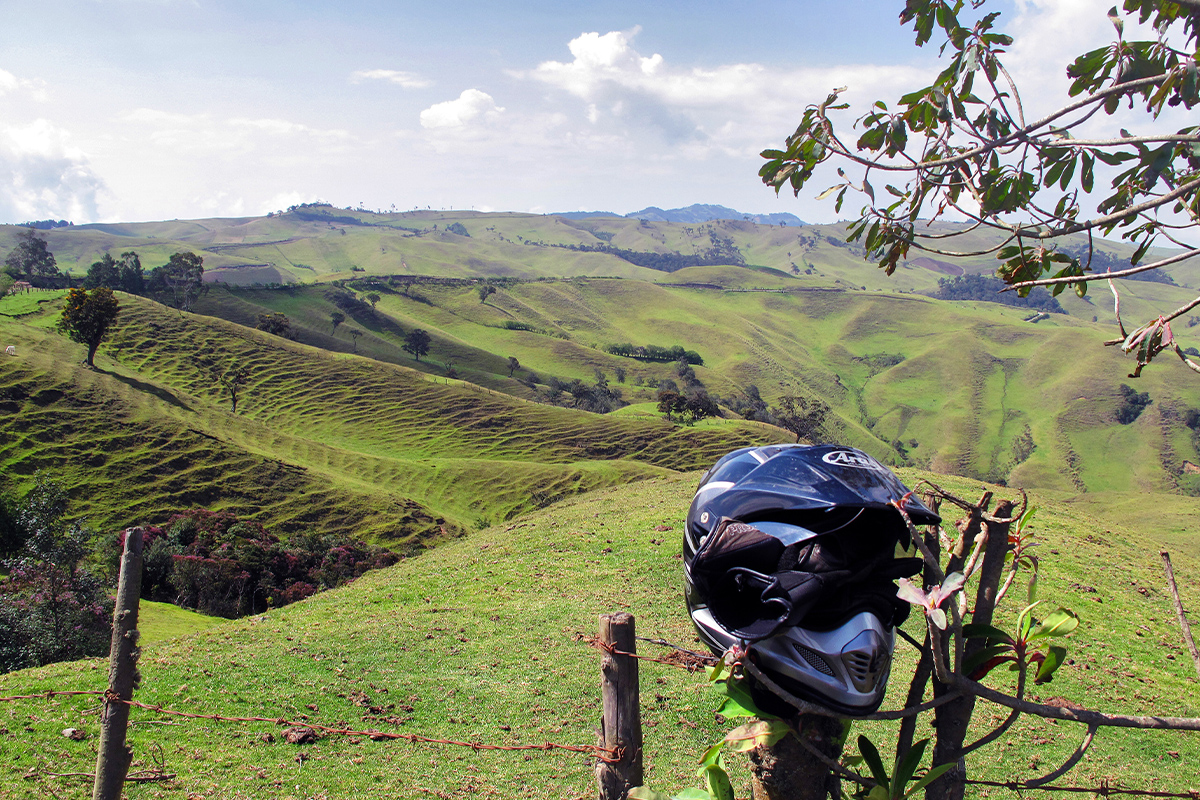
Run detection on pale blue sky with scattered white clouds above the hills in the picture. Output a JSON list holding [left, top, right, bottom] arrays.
[[0, 0, 1132, 222]]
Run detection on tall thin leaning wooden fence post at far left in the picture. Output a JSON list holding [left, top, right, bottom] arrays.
[[91, 528, 143, 800]]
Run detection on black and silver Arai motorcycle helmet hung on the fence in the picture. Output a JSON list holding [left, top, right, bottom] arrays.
[[684, 445, 938, 716]]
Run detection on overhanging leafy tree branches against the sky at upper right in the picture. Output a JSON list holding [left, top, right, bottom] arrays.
[[760, 0, 1200, 377]]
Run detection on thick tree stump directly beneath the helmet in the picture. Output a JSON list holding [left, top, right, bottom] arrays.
[[750, 714, 842, 800]]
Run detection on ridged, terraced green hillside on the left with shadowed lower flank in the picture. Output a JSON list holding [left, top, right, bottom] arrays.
[[0, 295, 784, 545]]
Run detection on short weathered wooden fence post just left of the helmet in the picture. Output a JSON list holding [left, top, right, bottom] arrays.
[[596, 612, 643, 800]]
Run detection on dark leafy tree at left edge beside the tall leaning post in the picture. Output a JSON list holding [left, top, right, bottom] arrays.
[[0, 475, 113, 672]]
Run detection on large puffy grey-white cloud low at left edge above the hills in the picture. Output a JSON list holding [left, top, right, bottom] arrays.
[[0, 120, 104, 222]]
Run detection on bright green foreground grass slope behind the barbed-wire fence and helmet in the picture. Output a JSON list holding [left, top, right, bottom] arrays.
[[0, 471, 1200, 799]]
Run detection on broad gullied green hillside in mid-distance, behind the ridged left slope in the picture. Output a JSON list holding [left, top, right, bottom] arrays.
[[196, 278, 1200, 492]]
